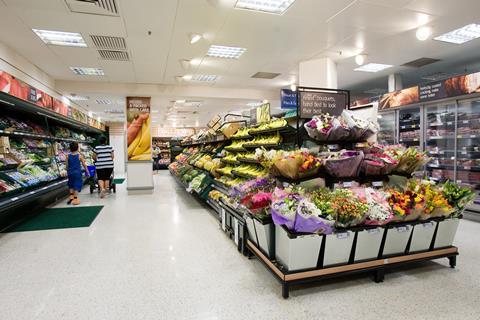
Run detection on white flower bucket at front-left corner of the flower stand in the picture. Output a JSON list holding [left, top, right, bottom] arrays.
[[275, 225, 323, 271]]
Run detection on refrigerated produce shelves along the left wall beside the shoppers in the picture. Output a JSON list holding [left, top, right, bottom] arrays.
[[0, 107, 100, 229]]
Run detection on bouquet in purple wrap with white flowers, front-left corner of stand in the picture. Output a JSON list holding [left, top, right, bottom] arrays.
[[294, 199, 335, 234]]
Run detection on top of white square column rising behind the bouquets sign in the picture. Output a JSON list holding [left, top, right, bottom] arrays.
[[298, 58, 338, 89]]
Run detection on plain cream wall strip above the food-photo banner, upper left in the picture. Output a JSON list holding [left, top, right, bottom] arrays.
[[0, 42, 56, 98]]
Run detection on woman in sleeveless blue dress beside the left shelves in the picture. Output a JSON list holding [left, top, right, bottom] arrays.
[[67, 142, 89, 205]]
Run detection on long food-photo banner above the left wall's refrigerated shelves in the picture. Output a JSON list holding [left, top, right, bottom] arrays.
[[0, 70, 105, 130]]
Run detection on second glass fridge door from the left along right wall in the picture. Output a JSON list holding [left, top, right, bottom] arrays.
[[398, 107, 422, 150]]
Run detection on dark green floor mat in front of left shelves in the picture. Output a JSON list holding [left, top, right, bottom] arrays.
[[5, 206, 103, 232]]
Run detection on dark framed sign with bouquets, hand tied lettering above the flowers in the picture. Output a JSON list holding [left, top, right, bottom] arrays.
[[299, 91, 347, 119]]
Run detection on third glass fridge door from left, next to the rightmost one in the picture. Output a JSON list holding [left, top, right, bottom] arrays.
[[425, 102, 456, 182]]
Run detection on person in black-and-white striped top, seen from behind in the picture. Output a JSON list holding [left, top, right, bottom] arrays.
[[93, 136, 113, 198]]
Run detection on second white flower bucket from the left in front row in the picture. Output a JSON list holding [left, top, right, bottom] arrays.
[[323, 231, 354, 267]]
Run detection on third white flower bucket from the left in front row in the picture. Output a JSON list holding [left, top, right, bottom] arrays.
[[354, 228, 385, 262]]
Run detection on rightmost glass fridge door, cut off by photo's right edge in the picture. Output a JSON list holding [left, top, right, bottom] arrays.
[[457, 99, 480, 211]]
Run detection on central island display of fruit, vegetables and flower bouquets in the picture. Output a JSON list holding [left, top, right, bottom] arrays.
[[169, 110, 475, 297]]
